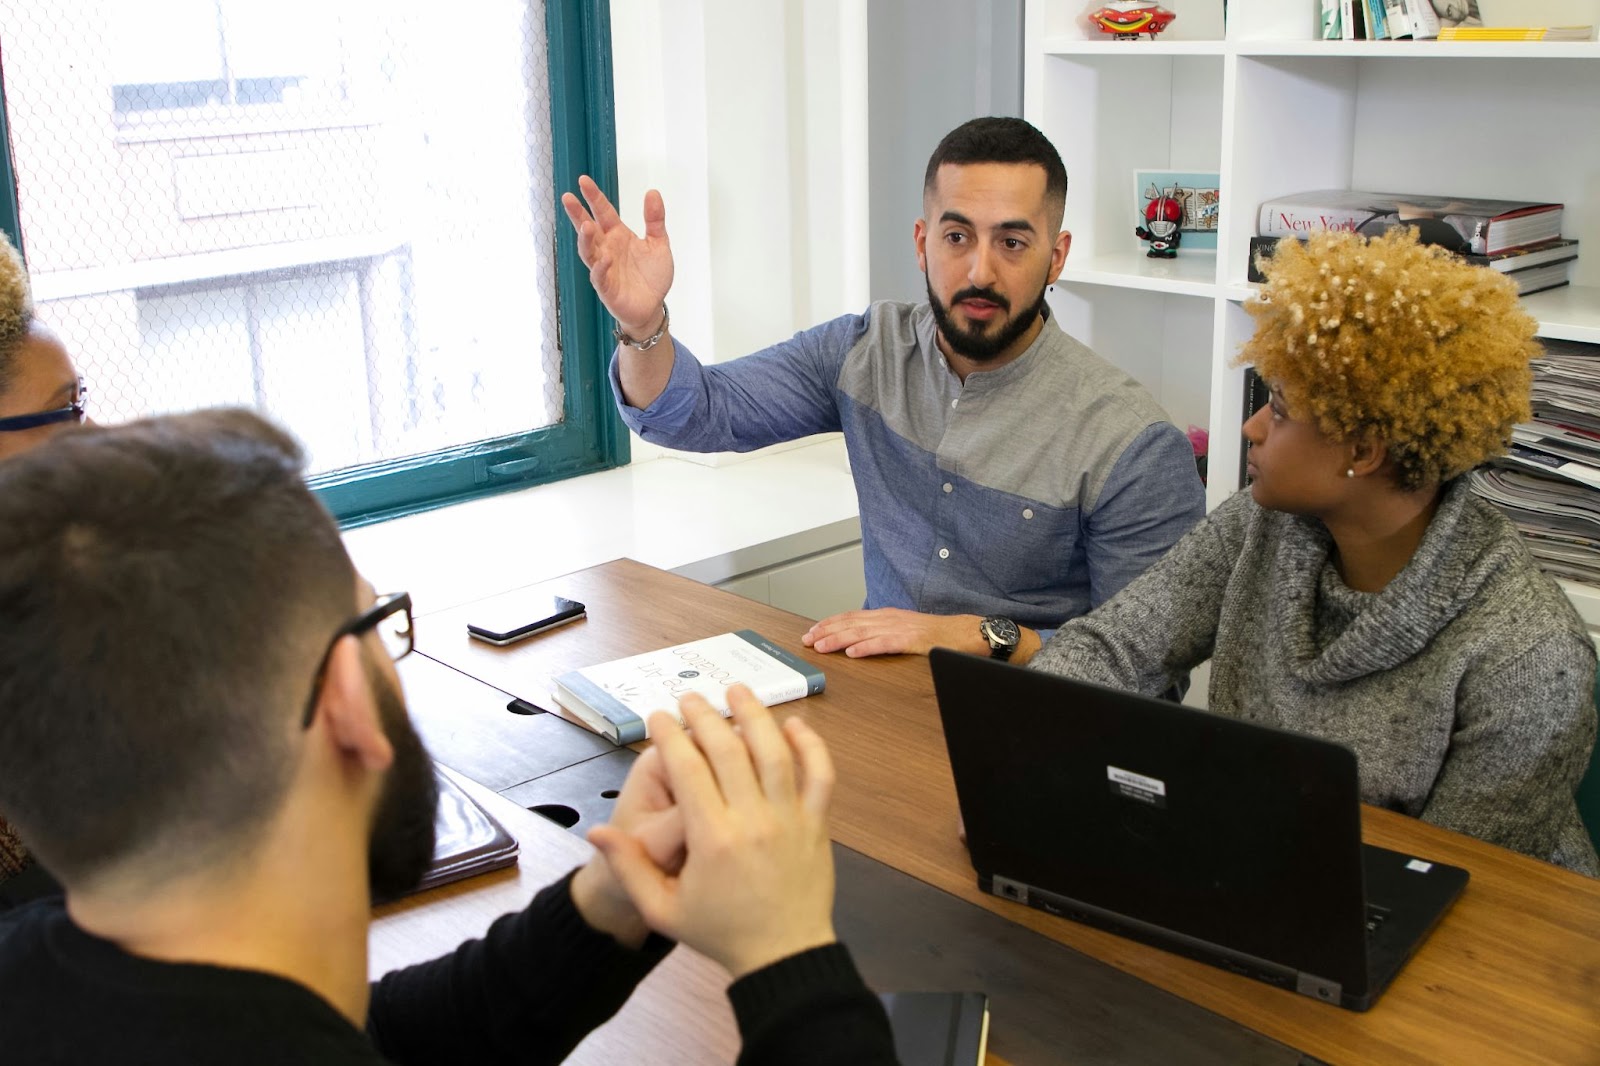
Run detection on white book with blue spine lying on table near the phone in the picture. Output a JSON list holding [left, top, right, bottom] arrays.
[[550, 629, 826, 744]]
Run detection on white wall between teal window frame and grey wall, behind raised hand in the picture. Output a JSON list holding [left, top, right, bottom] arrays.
[[611, 0, 869, 461]]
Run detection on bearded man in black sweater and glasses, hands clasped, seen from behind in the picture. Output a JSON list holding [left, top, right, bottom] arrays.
[[0, 410, 894, 1066]]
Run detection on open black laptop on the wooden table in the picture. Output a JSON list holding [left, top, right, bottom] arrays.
[[928, 648, 1467, 1010]]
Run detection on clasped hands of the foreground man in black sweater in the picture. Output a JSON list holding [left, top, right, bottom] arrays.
[[573, 685, 835, 978]]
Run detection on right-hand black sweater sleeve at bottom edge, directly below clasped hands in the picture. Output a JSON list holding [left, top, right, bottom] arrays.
[[728, 944, 898, 1066]]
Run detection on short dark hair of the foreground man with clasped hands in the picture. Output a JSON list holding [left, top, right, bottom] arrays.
[[0, 410, 357, 888]]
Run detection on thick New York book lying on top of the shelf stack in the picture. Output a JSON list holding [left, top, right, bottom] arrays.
[[1256, 189, 1562, 256]]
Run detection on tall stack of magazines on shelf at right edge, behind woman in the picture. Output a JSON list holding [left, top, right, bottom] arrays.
[[1470, 341, 1600, 584]]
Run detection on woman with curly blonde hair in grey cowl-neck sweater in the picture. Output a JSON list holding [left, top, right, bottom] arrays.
[[1030, 229, 1600, 876]]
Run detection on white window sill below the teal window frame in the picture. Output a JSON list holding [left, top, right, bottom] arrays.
[[344, 437, 861, 613]]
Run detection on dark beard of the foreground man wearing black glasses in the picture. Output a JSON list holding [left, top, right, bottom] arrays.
[[366, 661, 438, 903]]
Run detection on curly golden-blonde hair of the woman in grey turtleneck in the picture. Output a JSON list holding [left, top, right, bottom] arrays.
[[1235, 227, 1541, 490]]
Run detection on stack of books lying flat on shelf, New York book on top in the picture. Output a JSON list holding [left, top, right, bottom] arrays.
[[1250, 189, 1578, 296]]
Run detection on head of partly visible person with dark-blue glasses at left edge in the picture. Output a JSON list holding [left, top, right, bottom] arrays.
[[0, 228, 85, 460]]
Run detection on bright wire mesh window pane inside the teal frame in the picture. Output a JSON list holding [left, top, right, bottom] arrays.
[[0, 0, 563, 474]]
